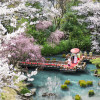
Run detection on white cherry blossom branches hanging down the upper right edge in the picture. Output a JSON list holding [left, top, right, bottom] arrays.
[[72, 0, 100, 53]]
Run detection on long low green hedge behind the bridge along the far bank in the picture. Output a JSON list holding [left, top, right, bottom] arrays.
[[42, 35, 91, 56]]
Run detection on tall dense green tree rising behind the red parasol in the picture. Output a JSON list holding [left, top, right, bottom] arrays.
[[60, 1, 91, 51]]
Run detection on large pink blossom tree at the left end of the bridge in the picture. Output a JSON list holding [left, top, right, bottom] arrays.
[[2, 34, 44, 64]]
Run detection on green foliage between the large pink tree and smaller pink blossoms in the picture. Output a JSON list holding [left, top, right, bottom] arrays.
[[27, 22, 56, 45]]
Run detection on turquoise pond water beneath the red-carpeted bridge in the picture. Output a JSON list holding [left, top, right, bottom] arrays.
[[30, 55, 100, 100]]
